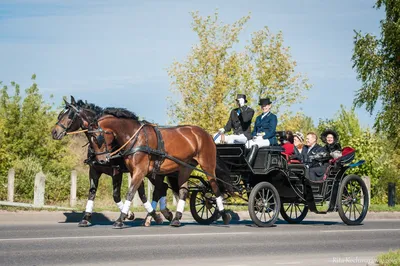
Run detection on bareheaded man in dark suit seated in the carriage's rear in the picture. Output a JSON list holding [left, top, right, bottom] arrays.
[[302, 132, 329, 181]]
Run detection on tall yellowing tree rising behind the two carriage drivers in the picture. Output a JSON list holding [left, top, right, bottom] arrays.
[[168, 12, 310, 131]]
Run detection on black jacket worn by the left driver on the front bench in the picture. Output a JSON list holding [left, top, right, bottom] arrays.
[[224, 105, 254, 139]]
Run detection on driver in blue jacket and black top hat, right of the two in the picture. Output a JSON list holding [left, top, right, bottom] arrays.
[[248, 98, 278, 148]]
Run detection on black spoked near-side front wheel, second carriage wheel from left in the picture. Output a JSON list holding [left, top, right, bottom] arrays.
[[249, 182, 281, 227]]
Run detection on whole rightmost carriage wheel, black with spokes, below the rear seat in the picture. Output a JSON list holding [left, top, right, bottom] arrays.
[[338, 175, 369, 225]]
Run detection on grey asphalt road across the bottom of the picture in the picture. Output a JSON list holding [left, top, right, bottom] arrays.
[[0, 217, 400, 266]]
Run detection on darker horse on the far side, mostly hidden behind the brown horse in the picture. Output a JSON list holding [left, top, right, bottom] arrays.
[[52, 96, 178, 227]]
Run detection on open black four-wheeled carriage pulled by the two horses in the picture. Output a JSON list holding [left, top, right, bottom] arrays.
[[190, 144, 369, 227]]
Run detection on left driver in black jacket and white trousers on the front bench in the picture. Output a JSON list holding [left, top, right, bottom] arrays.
[[215, 94, 254, 144]]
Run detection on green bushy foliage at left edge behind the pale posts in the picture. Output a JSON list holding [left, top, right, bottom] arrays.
[[0, 75, 78, 201]]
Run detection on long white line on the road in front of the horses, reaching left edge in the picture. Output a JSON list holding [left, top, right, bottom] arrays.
[[0, 232, 253, 242]]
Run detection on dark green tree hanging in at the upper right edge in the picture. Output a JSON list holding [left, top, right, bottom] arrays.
[[352, 0, 400, 139]]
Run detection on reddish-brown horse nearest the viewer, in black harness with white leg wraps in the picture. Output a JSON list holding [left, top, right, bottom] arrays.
[[91, 108, 231, 227]]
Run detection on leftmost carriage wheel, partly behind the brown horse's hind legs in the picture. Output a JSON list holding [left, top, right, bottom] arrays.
[[190, 190, 218, 225]]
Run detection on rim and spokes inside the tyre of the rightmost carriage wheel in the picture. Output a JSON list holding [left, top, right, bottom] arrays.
[[341, 180, 365, 221]]
